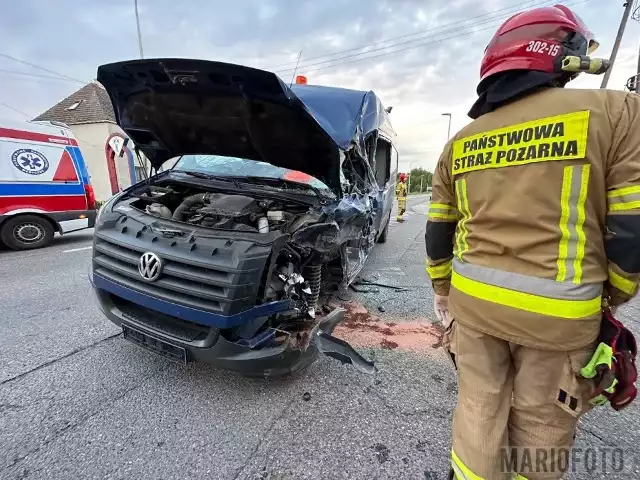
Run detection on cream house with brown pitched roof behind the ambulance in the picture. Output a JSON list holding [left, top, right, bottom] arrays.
[[33, 81, 149, 201]]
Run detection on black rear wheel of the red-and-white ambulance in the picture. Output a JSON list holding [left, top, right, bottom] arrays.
[[0, 215, 55, 250]]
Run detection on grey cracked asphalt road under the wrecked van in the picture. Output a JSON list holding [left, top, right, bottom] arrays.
[[0, 197, 640, 480]]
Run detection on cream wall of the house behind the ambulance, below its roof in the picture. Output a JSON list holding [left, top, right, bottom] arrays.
[[70, 122, 154, 201]]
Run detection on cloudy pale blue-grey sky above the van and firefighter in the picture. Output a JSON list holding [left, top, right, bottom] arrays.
[[0, 0, 640, 171]]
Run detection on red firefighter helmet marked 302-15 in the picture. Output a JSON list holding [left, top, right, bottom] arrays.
[[480, 5, 599, 82]]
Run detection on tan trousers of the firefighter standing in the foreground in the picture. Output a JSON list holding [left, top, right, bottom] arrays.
[[443, 319, 595, 480]]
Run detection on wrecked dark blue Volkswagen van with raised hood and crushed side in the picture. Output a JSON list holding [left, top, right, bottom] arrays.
[[90, 59, 398, 376]]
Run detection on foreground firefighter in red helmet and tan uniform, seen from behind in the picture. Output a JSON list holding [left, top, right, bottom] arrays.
[[425, 5, 640, 480]]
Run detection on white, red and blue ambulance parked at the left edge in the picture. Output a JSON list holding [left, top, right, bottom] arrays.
[[0, 120, 96, 250]]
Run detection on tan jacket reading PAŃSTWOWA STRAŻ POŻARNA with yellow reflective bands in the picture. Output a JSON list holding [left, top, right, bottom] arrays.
[[425, 88, 640, 350]]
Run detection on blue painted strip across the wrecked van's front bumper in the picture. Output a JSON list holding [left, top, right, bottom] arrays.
[[92, 273, 291, 328]]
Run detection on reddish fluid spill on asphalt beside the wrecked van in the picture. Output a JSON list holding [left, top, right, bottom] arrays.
[[333, 302, 444, 354]]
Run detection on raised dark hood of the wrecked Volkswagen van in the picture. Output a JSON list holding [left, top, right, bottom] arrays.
[[97, 59, 340, 189]]
